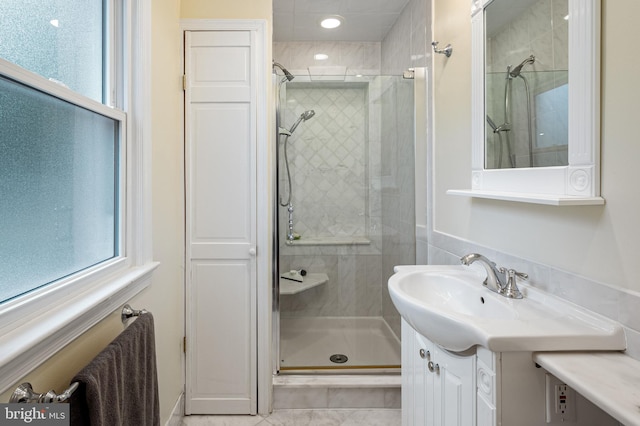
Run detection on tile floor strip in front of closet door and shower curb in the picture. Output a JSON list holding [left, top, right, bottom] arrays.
[[182, 409, 402, 426]]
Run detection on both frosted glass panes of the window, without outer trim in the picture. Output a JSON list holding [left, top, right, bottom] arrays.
[[0, 0, 124, 302]]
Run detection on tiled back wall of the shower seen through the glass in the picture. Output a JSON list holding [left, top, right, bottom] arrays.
[[280, 80, 383, 317]]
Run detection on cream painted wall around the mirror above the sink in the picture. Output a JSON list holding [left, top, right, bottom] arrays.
[[433, 0, 640, 291]]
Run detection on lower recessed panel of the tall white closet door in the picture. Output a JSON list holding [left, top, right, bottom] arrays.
[[191, 261, 253, 413]]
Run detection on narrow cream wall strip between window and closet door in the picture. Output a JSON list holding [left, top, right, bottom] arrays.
[[151, 0, 185, 422]]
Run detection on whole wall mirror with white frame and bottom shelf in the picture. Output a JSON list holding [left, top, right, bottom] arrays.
[[449, 0, 604, 205]]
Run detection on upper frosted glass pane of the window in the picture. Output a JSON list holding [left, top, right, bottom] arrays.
[[0, 0, 106, 102]]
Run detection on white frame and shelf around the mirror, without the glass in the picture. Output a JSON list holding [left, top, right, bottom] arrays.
[[447, 0, 604, 205]]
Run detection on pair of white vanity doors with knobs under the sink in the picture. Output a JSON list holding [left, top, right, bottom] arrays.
[[402, 320, 476, 426]]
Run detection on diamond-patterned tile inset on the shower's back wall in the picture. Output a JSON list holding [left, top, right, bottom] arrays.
[[280, 83, 369, 239]]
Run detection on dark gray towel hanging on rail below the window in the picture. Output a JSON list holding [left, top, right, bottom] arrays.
[[70, 313, 160, 426]]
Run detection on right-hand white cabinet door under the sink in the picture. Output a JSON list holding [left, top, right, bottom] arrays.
[[429, 346, 476, 426]]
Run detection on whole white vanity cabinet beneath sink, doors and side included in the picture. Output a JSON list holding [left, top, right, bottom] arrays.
[[402, 319, 618, 426]]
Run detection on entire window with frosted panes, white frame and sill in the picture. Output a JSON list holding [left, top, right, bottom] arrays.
[[0, 0, 156, 391]]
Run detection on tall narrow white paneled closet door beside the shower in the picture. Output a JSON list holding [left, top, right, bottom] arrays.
[[185, 31, 257, 414]]
